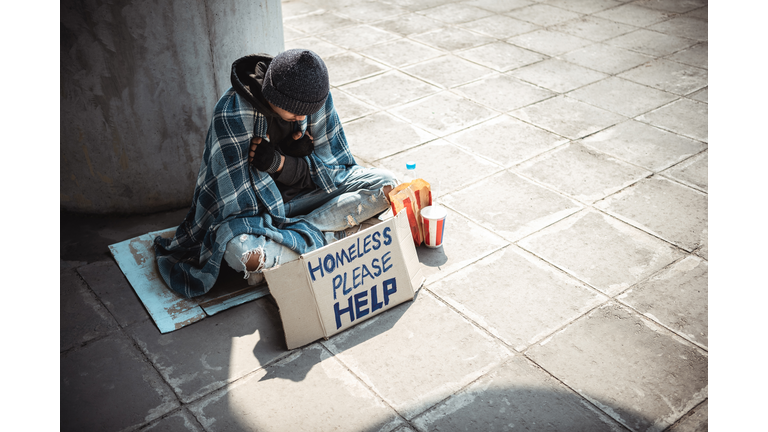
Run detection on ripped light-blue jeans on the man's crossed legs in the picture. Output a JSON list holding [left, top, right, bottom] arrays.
[[224, 167, 398, 283]]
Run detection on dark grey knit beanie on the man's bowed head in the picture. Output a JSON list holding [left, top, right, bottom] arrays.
[[261, 49, 329, 115]]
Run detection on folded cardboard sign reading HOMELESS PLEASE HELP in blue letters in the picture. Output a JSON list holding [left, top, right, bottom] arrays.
[[264, 213, 424, 349]]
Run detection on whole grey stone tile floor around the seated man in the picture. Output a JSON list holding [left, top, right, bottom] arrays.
[[60, 0, 709, 432]]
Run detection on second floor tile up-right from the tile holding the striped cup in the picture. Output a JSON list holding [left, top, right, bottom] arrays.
[[518, 143, 651, 202]]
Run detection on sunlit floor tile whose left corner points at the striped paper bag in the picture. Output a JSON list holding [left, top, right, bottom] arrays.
[[443, 171, 581, 241]]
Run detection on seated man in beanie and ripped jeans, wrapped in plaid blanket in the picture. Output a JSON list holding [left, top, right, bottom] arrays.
[[154, 49, 397, 298]]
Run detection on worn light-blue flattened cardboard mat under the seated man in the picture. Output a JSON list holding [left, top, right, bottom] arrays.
[[109, 228, 269, 333]]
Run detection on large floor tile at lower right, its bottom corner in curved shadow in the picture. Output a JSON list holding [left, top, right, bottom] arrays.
[[527, 304, 708, 431]]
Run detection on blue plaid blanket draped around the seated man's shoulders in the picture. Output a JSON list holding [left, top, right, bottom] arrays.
[[154, 88, 357, 298]]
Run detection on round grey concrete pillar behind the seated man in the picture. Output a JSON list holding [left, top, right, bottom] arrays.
[[59, 0, 284, 214]]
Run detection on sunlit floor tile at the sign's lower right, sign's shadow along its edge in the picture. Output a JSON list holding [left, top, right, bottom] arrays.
[[323, 291, 511, 419]]
